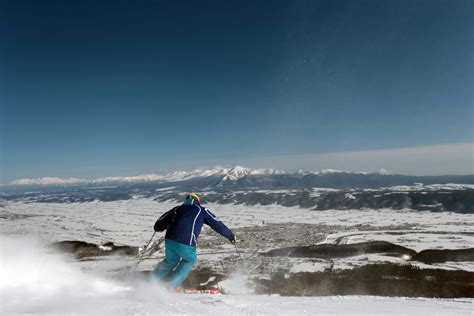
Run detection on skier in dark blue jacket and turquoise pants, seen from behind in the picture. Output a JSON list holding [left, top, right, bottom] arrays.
[[153, 193, 235, 290]]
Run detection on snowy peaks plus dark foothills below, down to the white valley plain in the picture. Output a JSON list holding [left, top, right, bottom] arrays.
[[0, 166, 474, 213]]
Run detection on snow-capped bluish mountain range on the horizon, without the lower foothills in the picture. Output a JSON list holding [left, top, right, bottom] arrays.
[[3, 166, 474, 191]]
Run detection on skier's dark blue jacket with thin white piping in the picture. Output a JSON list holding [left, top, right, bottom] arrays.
[[154, 204, 234, 246]]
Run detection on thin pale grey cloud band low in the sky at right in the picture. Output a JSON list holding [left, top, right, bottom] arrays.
[[241, 143, 474, 175]]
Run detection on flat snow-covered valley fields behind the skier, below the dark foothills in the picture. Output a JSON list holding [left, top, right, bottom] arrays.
[[0, 198, 474, 250]]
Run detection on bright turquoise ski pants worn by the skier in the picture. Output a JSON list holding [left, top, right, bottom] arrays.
[[153, 239, 197, 289]]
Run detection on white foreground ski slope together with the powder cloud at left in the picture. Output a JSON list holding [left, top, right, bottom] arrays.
[[0, 236, 474, 315]]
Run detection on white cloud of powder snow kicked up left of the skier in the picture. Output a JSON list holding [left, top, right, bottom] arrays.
[[0, 235, 176, 315]]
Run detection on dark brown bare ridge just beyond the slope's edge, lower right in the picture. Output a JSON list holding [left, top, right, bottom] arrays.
[[255, 264, 474, 298]]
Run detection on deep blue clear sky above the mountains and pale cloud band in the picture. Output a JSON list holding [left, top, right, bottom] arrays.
[[0, 0, 474, 183]]
